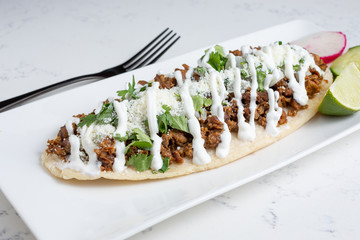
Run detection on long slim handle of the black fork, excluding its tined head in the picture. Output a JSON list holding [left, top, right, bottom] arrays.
[[0, 74, 106, 112]]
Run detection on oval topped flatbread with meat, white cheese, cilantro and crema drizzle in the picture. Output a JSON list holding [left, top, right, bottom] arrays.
[[42, 41, 332, 180]]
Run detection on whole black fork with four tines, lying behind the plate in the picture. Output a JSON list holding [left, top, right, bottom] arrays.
[[0, 28, 180, 112]]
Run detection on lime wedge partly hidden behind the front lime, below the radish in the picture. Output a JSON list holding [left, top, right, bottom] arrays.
[[330, 46, 360, 77]]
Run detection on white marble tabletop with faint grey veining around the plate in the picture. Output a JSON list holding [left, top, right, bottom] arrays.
[[0, 0, 360, 240]]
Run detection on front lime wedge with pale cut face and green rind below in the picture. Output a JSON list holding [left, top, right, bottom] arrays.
[[319, 63, 360, 116]]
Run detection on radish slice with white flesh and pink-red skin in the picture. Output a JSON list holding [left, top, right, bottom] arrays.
[[292, 32, 346, 63]]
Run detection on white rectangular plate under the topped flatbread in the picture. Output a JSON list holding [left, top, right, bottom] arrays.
[[0, 21, 360, 240]]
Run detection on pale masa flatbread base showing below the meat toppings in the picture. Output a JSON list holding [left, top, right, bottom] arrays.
[[41, 69, 333, 180]]
